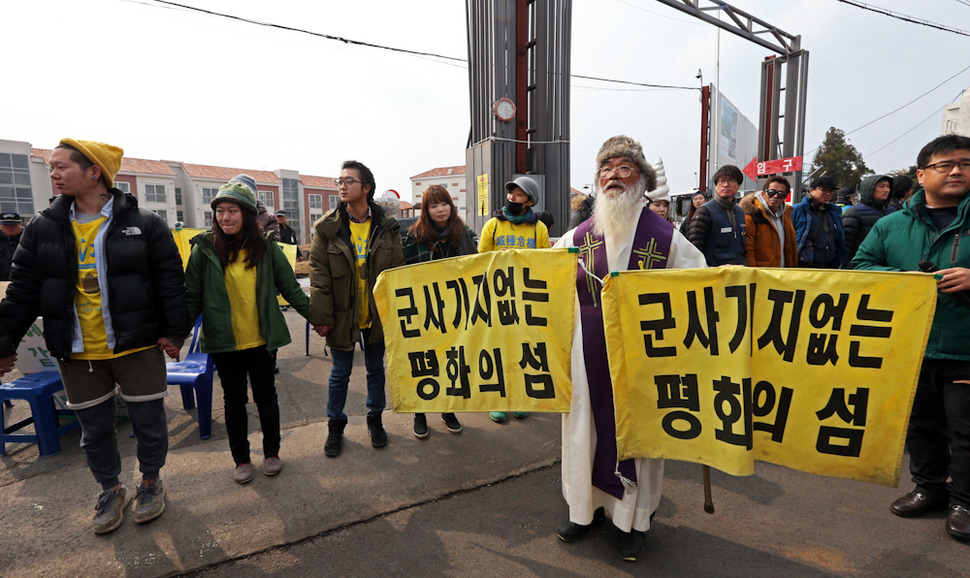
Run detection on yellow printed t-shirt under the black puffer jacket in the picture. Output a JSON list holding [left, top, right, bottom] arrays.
[[71, 217, 154, 359]]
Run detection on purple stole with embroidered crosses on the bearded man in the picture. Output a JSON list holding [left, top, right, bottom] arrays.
[[573, 207, 674, 500]]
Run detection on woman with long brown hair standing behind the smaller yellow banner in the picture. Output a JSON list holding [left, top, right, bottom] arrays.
[[404, 185, 478, 439]]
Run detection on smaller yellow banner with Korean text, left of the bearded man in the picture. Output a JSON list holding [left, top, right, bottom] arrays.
[[374, 249, 577, 413]]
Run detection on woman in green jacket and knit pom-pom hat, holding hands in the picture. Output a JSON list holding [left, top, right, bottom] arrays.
[[185, 180, 309, 484]]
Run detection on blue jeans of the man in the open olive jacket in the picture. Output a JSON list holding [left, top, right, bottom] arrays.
[[327, 329, 385, 421]]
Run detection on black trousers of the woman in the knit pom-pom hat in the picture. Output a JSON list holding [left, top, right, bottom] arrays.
[[212, 345, 280, 464]]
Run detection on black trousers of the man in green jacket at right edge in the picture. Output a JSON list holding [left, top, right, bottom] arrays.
[[906, 359, 970, 507]]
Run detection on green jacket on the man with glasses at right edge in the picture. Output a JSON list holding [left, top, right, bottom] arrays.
[[852, 191, 970, 361]]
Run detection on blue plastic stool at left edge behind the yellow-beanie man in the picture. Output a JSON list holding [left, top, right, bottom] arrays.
[[0, 371, 81, 456]]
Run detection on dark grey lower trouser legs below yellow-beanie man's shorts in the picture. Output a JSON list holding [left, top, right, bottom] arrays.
[[74, 397, 168, 490]]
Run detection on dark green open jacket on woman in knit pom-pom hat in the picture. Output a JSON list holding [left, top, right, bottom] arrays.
[[185, 231, 310, 353]]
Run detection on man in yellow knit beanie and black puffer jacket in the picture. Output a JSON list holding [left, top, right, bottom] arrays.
[[0, 139, 191, 534]]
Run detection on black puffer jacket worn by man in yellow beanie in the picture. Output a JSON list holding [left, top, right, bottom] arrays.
[[0, 189, 192, 360]]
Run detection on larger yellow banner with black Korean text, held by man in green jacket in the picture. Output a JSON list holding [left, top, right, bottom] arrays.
[[603, 267, 936, 487]]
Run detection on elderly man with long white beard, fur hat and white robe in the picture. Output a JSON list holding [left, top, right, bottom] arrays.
[[555, 136, 706, 561]]
